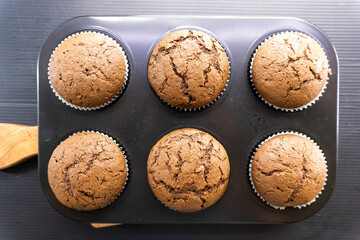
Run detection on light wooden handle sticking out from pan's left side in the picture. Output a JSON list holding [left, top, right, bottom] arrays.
[[0, 123, 38, 170]]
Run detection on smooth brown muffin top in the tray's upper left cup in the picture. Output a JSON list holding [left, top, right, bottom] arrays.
[[49, 33, 127, 108]]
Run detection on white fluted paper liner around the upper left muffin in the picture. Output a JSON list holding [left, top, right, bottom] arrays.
[[47, 31, 129, 111]]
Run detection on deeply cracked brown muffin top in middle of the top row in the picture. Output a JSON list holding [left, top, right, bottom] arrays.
[[148, 30, 229, 109]]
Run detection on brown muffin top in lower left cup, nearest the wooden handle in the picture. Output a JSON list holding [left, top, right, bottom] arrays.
[[48, 132, 127, 211]]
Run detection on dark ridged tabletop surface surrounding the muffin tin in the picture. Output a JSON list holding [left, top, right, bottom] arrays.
[[0, 0, 360, 239]]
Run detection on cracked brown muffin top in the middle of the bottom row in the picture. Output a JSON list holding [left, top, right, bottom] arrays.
[[147, 128, 230, 212]]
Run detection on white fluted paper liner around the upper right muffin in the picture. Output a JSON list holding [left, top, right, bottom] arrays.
[[249, 31, 330, 112]]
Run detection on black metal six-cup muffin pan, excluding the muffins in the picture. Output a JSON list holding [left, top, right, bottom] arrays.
[[38, 16, 339, 223]]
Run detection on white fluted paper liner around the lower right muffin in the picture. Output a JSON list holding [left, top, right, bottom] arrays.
[[249, 131, 328, 210]]
